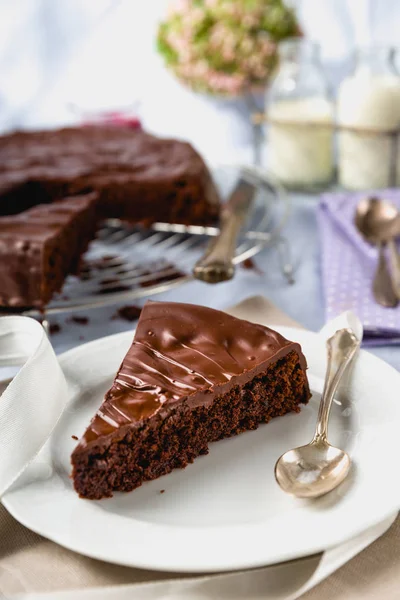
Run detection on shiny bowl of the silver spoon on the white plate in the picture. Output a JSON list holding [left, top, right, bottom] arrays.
[[275, 440, 351, 498]]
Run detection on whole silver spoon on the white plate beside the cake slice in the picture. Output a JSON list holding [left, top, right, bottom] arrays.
[[275, 329, 360, 498]]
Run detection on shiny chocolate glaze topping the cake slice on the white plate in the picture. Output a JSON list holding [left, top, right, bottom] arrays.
[[76, 302, 307, 450]]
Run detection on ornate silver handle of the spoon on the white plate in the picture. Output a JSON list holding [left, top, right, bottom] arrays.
[[313, 329, 360, 442]]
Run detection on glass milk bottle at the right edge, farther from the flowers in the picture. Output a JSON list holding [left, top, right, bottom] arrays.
[[337, 47, 400, 190]]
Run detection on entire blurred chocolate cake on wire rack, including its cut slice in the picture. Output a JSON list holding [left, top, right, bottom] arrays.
[[0, 125, 219, 308]]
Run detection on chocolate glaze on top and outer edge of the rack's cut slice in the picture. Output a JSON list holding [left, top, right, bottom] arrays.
[[0, 193, 97, 307]]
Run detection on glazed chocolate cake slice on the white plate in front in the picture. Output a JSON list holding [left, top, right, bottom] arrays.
[[72, 302, 310, 499]]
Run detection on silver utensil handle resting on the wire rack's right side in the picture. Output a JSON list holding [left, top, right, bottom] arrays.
[[193, 178, 257, 283]]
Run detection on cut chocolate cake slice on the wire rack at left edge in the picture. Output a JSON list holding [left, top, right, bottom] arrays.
[[0, 192, 98, 308]]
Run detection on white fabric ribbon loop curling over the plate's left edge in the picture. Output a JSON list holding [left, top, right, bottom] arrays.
[[0, 316, 68, 497]]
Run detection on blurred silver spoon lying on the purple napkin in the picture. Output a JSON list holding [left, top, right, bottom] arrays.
[[355, 198, 400, 307]]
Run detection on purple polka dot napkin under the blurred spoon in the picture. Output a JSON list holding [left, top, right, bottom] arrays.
[[317, 189, 400, 346]]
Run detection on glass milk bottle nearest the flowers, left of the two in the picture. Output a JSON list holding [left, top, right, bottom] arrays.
[[266, 39, 334, 189]]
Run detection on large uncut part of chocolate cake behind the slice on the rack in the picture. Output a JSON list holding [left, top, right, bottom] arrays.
[[0, 125, 219, 225]]
